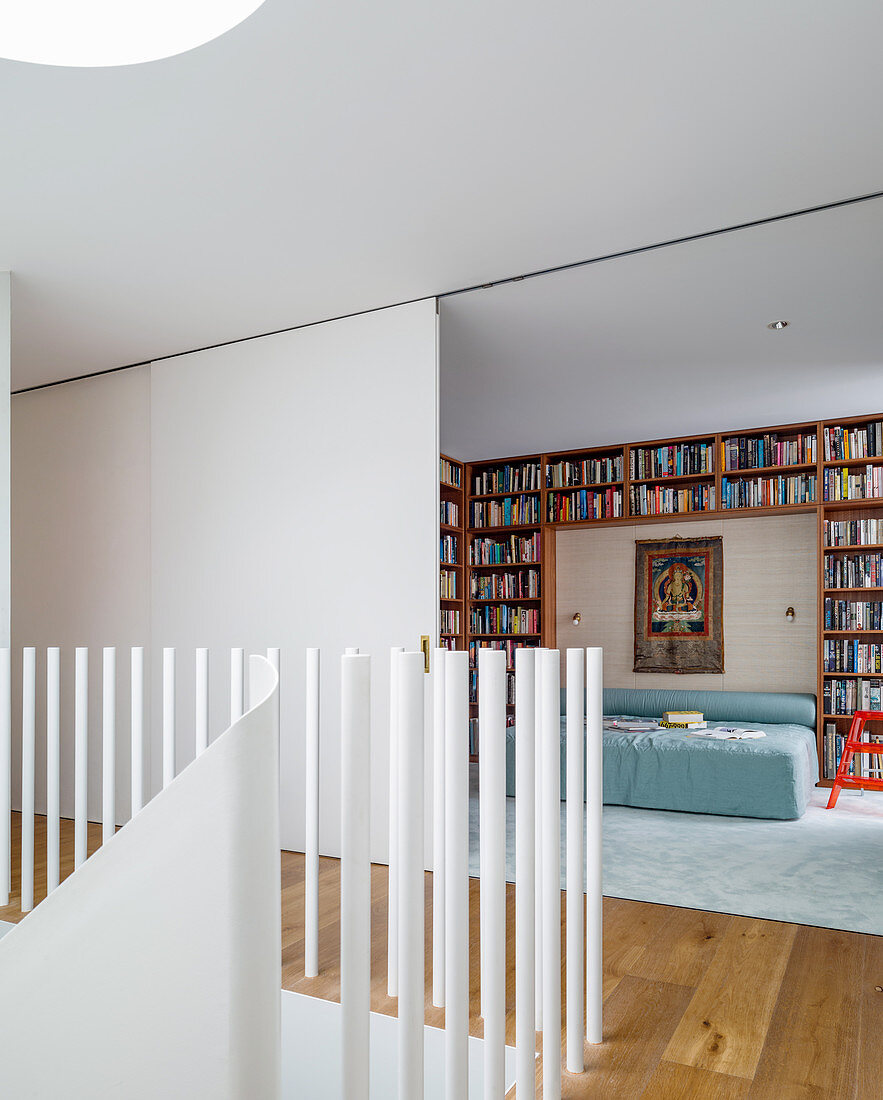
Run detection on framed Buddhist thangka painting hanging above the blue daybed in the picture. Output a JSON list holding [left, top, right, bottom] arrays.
[[634, 536, 724, 672]]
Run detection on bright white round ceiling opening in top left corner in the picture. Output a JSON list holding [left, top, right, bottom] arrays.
[[0, 0, 264, 68]]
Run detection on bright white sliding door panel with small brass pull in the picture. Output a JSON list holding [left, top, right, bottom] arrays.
[[151, 300, 438, 859]]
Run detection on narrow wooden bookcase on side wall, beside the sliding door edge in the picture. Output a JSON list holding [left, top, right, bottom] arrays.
[[439, 454, 466, 649]]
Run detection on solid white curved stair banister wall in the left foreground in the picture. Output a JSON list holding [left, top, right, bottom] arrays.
[[0, 658, 282, 1100]]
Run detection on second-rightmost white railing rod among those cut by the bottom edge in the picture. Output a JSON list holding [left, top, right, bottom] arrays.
[[515, 649, 537, 1097]]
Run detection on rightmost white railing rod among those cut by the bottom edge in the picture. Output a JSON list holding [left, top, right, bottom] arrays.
[[540, 649, 561, 1100]]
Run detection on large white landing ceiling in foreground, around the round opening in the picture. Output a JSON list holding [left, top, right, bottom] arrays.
[[0, 0, 883, 387]]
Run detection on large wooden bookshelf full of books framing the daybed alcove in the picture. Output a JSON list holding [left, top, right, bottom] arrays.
[[453, 414, 883, 785]]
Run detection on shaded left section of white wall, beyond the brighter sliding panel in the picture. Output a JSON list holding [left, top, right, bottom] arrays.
[[12, 367, 151, 822]]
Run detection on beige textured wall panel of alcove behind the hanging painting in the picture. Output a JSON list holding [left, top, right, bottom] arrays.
[[556, 515, 816, 692]]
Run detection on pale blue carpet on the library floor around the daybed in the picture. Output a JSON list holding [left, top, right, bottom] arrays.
[[470, 766, 883, 935]]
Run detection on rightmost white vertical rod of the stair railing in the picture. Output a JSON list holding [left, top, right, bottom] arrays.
[[586, 647, 604, 1043]]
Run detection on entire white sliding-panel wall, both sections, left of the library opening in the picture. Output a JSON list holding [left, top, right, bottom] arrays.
[[13, 299, 438, 859]]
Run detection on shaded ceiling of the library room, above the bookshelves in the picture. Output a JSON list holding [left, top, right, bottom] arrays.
[[440, 199, 883, 460]]
